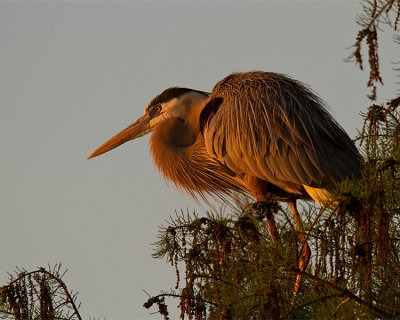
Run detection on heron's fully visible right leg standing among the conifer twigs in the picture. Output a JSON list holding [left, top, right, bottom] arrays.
[[288, 201, 311, 304]]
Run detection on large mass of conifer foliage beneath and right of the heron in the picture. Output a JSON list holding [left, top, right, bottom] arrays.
[[144, 0, 400, 320]]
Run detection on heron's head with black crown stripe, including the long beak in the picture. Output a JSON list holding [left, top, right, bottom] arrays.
[[88, 87, 208, 159]]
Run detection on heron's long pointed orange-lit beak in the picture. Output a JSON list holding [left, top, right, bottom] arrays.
[[87, 115, 151, 160]]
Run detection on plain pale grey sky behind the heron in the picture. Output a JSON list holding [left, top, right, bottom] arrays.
[[0, 0, 398, 319]]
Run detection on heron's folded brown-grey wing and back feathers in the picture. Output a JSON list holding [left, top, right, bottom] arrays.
[[201, 72, 359, 195]]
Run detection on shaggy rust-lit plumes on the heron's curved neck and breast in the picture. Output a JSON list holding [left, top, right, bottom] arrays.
[[150, 119, 247, 201]]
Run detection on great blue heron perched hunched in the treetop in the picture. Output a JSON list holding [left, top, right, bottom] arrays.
[[89, 71, 360, 298]]
